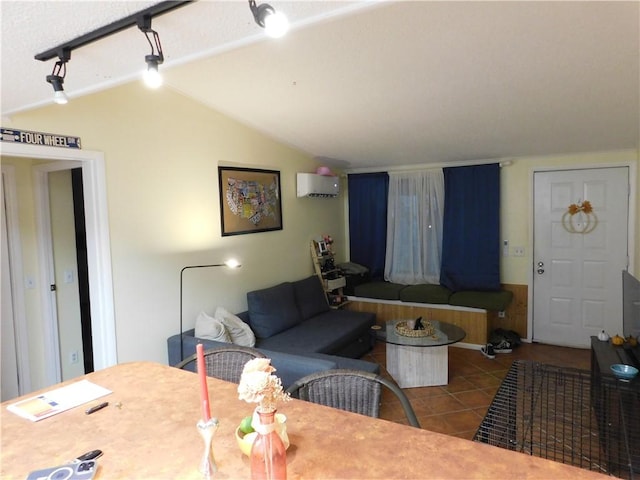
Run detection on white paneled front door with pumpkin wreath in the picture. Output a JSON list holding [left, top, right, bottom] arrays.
[[532, 167, 629, 347]]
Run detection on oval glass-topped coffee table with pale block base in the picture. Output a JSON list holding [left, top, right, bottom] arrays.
[[379, 320, 466, 388]]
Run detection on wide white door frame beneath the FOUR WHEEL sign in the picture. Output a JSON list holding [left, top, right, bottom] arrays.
[[0, 143, 118, 376]]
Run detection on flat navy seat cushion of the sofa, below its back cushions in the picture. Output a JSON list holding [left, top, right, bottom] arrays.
[[258, 310, 375, 353]]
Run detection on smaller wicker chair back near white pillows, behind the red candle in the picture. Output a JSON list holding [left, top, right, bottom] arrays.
[[175, 345, 265, 383]]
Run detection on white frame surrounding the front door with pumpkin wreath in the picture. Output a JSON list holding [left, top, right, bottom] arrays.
[[526, 161, 638, 343]]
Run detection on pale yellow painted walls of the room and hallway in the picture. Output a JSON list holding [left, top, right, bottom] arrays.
[[2, 0, 640, 400]]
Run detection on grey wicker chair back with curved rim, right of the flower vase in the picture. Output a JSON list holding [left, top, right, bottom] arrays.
[[287, 369, 420, 428]]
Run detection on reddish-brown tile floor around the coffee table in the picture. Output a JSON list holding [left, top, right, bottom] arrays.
[[368, 342, 591, 439]]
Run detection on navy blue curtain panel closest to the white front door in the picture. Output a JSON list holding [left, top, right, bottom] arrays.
[[440, 163, 500, 291]]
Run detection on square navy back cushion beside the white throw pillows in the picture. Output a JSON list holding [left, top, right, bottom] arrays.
[[247, 282, 301, 338]]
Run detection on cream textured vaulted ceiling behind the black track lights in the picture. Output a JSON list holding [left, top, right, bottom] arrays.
[[0, 0, 640, 169]]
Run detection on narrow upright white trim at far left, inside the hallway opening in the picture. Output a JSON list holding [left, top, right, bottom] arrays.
[[2, 165, 31, 395]]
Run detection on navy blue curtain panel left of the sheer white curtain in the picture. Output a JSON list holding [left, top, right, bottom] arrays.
[[348, 173, 389, 279]]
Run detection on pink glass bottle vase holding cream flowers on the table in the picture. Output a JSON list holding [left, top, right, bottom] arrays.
[[238, 358, 290, 480]]
